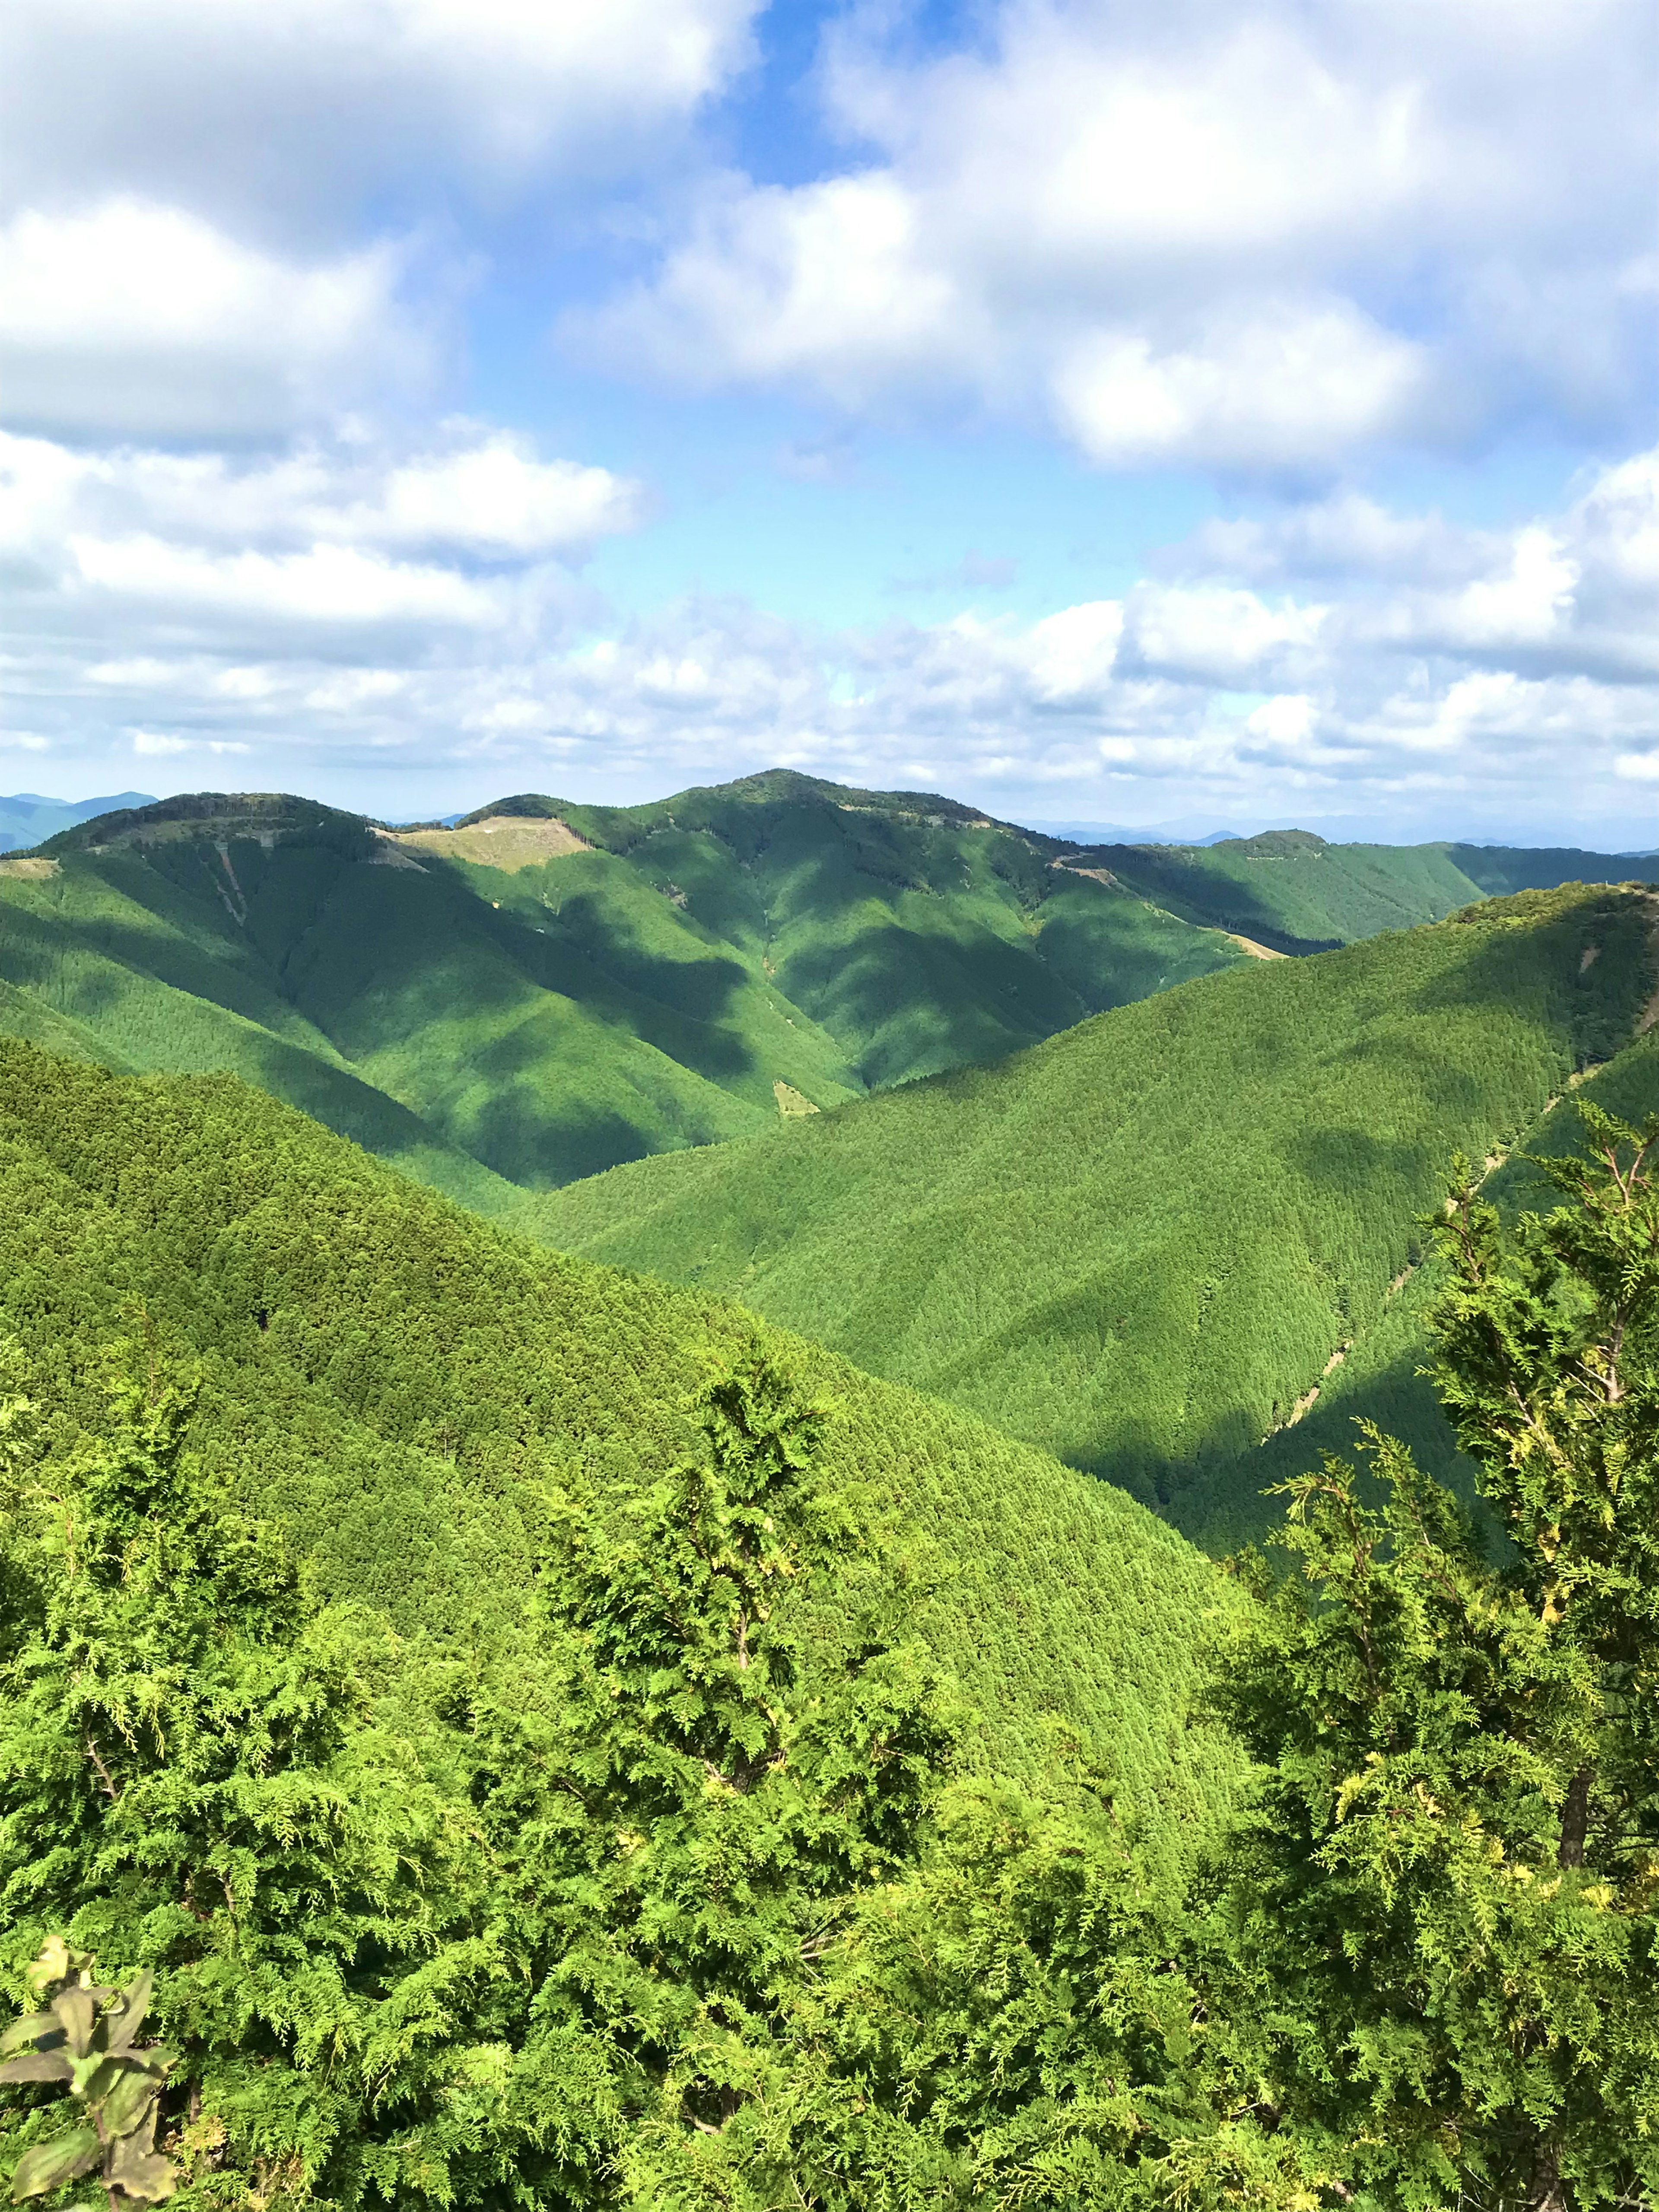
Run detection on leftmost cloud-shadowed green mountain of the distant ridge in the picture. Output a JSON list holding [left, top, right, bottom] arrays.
[[0, 796, 856, 1195]]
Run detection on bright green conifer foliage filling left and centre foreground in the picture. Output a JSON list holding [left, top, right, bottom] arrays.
[[0, 1292, 1239, 2212]]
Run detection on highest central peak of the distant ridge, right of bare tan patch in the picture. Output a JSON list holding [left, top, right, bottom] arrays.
[[434, 770, 1248, 1086]]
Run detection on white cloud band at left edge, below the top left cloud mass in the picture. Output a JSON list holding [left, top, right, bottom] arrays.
[[0, 425, 639, 672]]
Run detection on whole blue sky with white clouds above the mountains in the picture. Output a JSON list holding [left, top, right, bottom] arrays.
[[0, 0, 1659, 849]]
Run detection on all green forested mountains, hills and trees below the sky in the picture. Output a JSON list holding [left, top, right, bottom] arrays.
[[0, 774, 1659, 2212]]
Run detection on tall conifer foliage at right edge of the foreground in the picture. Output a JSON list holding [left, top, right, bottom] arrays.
[[1214, 1108, 1659, 2212]]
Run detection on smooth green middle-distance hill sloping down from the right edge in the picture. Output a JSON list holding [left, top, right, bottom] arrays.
[[518, 885, 1659, 1548]]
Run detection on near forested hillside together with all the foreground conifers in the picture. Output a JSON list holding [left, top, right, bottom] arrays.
[[0, 1046, 1659, 2212]]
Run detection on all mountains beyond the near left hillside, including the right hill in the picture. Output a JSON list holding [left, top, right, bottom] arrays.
[[0, 772, 1655, 1551]]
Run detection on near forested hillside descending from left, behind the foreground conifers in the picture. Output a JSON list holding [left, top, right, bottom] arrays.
[[0, 1042, 1230, 1867]]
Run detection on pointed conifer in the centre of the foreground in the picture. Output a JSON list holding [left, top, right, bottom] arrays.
[[474, 1345, 951, 2212]]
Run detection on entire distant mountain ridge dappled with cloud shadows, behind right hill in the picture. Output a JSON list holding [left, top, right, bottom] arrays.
[[0, 770, 1654, 1208]]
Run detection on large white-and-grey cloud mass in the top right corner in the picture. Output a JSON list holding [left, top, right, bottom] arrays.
[[569, 0, 1655, 469]]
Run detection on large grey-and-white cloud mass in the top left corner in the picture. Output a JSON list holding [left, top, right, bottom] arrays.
[[0, 0, 754, 440]]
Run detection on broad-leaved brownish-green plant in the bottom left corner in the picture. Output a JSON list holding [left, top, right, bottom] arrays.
[[0, 1936, 177, 2212]]
